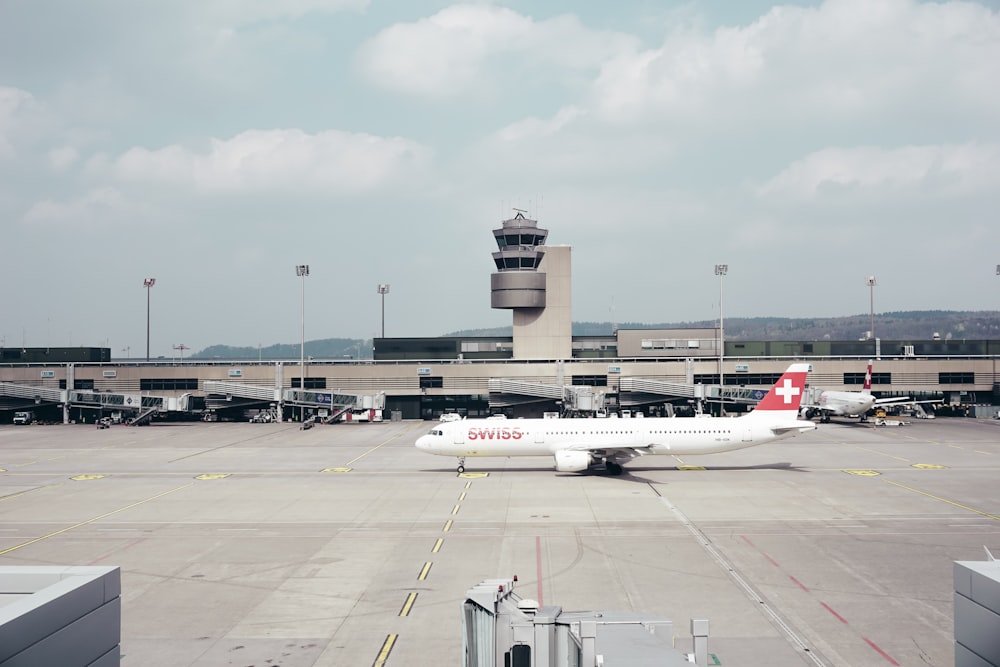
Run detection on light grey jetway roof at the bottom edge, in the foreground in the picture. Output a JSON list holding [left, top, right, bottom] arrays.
[[462, 577, 708, 667]]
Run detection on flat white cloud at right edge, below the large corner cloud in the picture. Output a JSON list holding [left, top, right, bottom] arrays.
[[758, 144, 1000, 199]]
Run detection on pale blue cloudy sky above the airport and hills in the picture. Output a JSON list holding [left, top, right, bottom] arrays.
[[0, 0, 1000, 356]]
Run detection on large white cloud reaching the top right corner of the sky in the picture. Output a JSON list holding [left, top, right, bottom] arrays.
[[593, 0, 1000, 131]]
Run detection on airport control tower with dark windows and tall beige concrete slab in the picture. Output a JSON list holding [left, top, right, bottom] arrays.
[[490, 209, 573, 359]]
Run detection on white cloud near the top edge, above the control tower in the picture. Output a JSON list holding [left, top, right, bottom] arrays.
[[356, 5, 636, 98]]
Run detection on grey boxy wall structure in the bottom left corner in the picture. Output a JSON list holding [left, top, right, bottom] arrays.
[[0, 566, 122, 667]]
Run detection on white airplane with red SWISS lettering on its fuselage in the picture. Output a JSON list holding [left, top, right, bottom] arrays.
[[416, 364, 816, 475]]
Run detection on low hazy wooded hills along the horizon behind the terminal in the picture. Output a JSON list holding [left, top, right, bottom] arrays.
[[190, 310, 1000, 359]]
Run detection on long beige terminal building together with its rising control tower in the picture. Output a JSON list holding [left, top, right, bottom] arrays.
[[0, 211, 1000, 423]]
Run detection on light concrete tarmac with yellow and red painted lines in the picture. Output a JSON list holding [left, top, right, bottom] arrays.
[[0, 418, 1000, 667]]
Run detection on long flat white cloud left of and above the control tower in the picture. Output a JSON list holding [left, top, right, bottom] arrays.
[[106, 129, 431, 194]]
